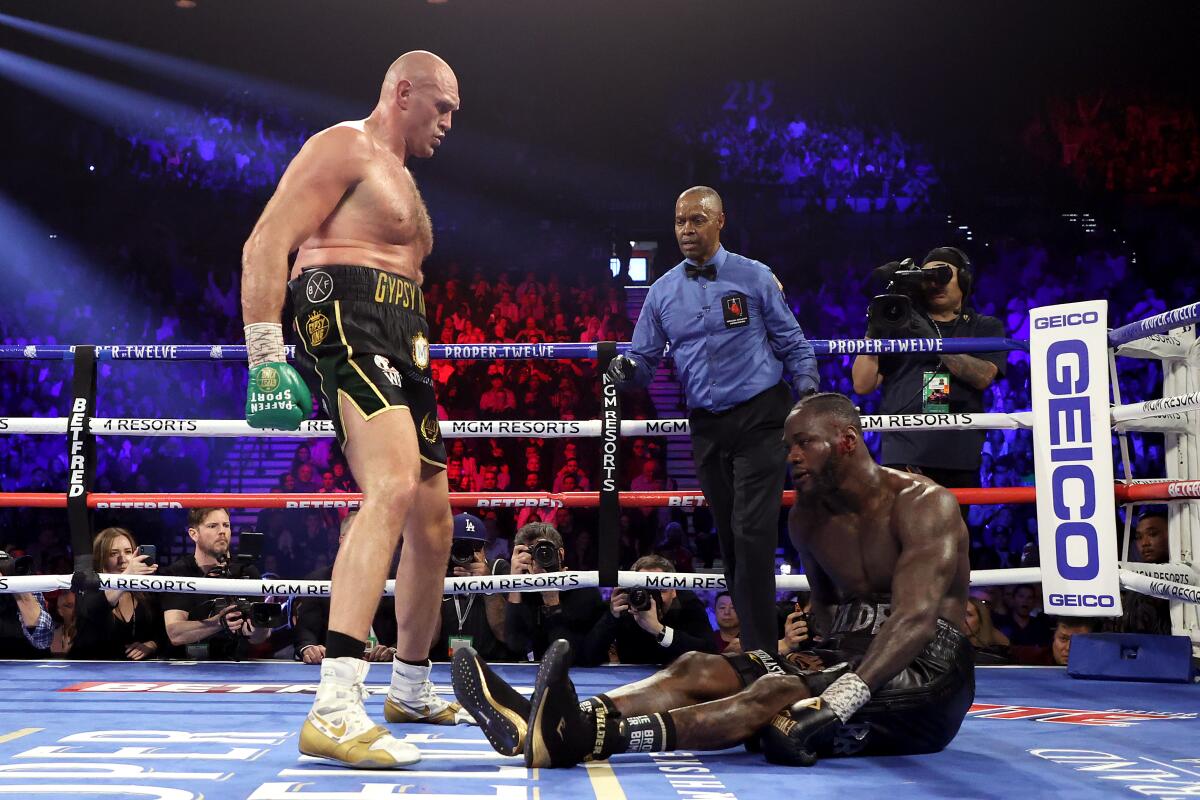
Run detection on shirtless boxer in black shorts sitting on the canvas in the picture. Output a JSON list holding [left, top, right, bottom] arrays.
[[452, 393, 974, 766]]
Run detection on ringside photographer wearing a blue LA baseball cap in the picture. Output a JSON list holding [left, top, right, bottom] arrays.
[[430, 513, 517, 661]]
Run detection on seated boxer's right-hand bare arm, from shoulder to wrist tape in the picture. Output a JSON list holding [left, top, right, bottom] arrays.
[[854, 486, 967, 692]]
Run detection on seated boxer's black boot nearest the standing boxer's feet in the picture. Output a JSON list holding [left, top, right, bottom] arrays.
[[450, 645, 529, 756]]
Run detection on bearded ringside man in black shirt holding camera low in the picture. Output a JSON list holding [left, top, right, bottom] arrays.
[[162, 509, 271, 661]]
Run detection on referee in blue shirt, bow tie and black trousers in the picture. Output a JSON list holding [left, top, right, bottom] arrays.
[[608, 186, 817, 652]]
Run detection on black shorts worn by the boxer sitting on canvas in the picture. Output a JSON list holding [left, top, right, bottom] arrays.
[[726, 597, 974, 758]]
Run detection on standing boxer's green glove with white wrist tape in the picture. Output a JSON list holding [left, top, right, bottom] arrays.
[[246, 323, 312, 431]]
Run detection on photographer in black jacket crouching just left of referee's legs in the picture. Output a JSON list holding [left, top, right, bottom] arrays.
[[580, 555, 715, 667]]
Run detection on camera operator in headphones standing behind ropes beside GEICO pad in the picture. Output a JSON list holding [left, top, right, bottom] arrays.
[[853, 247, 1008, 494]]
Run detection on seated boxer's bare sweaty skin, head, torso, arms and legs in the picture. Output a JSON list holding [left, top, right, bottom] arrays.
[[595, 396, 971, 750]]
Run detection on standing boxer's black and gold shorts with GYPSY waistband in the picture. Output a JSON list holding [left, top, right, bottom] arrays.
[[288, 265, 446, 468]]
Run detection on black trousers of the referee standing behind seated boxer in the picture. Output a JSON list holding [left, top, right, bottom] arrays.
[[688, 383, 792, 652]]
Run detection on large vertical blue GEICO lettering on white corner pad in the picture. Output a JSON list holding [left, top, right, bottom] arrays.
[[1046, 338, 1108, 581]]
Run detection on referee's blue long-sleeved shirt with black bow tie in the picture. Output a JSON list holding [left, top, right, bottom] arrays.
[[626, 247, 818, 411]]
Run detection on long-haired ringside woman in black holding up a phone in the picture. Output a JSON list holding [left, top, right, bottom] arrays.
[[71, 528, 167, 661]]
